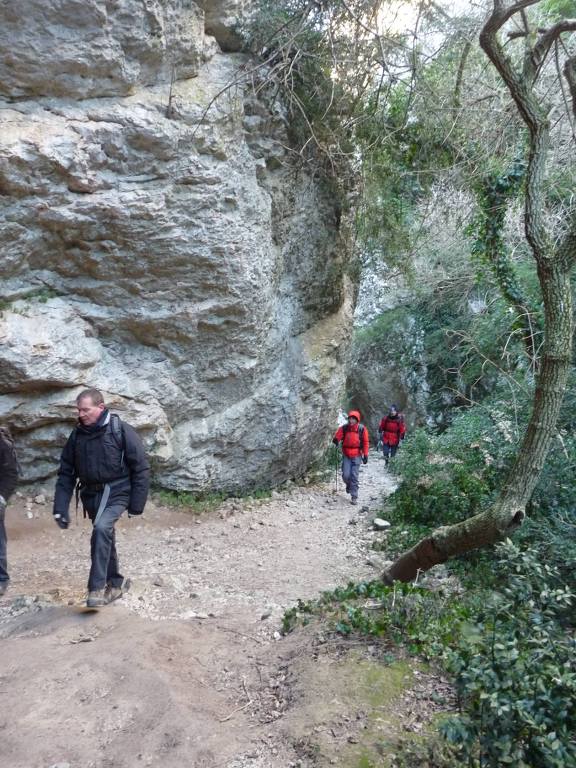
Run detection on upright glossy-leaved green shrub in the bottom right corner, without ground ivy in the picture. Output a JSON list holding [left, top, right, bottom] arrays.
[[442, 542, 576, 768]]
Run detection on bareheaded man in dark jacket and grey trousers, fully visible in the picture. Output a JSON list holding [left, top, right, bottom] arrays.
[[53, 389, 150, 608]]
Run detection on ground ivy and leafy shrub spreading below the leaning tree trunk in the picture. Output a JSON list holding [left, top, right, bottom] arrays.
[[283, 541, 576, 768]]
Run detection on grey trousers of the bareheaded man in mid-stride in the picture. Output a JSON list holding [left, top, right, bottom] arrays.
[[88, 504, 126, 592]]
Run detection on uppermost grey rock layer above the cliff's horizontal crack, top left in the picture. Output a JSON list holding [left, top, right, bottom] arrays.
[[0, 0, 204, 98]]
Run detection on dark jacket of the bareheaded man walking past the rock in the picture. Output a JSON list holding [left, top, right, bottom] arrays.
[[54, 411, 150, 517]]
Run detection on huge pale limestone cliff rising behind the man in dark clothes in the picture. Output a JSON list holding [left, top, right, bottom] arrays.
[[0, 0, 353, 491]]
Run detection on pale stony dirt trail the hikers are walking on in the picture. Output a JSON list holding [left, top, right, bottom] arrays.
[[0, 455, 400, 768]]
